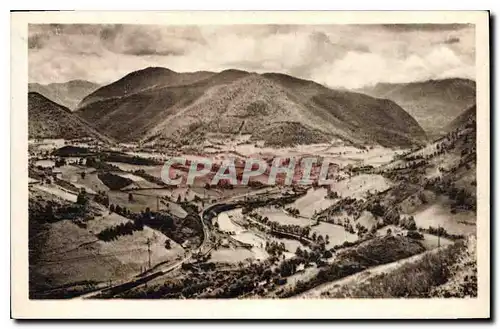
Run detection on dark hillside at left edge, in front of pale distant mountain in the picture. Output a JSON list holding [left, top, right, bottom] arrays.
[[28, 92, 110, 142]]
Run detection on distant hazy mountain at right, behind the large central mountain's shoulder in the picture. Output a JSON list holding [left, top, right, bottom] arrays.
[[360, 78, 476, 136]]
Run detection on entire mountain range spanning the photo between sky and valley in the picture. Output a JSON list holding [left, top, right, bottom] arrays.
[[29, 67, 475, 147]]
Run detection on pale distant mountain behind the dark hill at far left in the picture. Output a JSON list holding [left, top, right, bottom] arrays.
[[28, 80, 99, 111]]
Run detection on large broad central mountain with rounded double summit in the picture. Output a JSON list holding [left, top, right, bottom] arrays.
[[77, 68, 426, 146]]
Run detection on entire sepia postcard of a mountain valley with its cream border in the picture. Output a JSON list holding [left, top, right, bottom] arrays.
[[12, 12, 490, 318]]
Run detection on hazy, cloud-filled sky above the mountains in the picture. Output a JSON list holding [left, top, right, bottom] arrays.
[[28, 24, 475, 88]]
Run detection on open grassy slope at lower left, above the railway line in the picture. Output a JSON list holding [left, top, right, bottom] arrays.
[[29, 187, 182, 298]]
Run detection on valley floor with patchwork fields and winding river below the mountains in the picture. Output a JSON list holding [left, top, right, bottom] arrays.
[[29, 134, 477, 298]]
